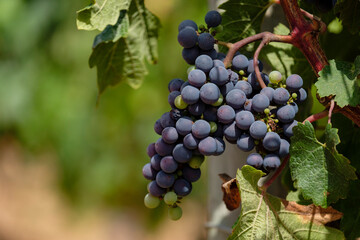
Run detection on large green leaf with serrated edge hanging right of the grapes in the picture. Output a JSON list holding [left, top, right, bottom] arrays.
[[289, 121, 357, 208]]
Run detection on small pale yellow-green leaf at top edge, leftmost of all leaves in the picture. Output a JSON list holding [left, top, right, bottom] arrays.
[[76, 0, 131, 31]]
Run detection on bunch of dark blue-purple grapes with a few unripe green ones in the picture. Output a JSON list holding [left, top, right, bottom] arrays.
[[143, 11, 307, 220]]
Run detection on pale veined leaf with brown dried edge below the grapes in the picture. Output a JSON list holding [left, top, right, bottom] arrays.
[[228, 165, 345, 240]]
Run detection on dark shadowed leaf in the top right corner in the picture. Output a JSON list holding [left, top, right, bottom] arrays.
[[335, 0, 360, 34]]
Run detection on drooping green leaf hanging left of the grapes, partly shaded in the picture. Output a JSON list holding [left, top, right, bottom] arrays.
[[89, 0, 160, 94]]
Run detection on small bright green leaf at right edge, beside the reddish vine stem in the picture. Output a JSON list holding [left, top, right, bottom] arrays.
[[315, 56, 360, 107]]
